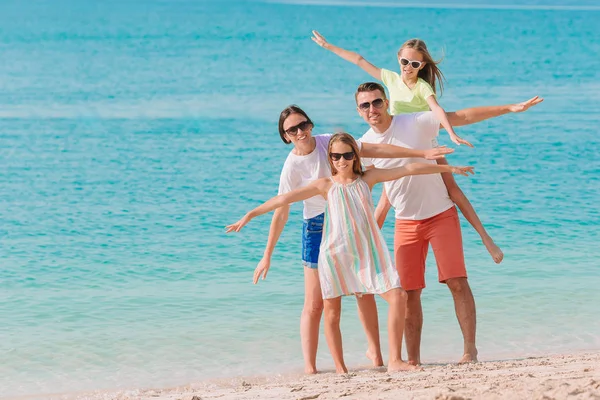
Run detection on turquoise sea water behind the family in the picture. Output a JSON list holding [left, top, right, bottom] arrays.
[[0, 0, 600, 398]]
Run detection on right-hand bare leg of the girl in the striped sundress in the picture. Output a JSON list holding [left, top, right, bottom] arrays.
[[381, 288, 421, 372]]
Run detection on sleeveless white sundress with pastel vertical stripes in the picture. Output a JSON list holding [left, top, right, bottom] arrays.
[[319, 177, 400, 299]]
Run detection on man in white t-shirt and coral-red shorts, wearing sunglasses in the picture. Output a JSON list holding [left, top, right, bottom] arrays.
[[355, 82, 543, 365]]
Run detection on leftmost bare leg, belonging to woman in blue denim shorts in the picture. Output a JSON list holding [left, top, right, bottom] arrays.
[[300, 267, 323, 374]]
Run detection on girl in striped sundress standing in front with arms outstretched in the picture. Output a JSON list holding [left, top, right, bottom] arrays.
[[226, 133, 473, 373]]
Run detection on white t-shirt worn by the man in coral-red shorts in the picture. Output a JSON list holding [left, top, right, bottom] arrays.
[[360, 111, 454, 220]]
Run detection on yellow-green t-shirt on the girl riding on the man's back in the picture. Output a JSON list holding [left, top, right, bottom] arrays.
[[381, 68, 435, 115]]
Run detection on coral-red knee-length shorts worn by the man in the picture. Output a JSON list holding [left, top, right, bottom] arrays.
[[394, 207, 467, 290]]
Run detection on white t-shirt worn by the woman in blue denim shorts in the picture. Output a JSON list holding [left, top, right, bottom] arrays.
[[279, 134, 332, 219]]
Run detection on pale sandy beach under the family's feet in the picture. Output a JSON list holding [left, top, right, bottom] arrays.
[[68, 353, 600, 400]]
